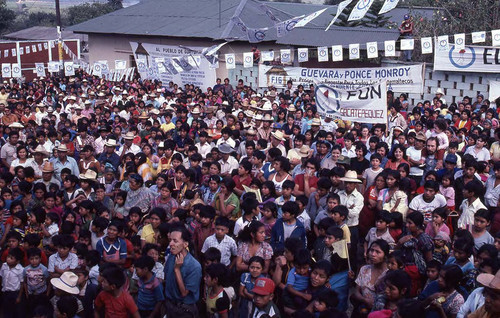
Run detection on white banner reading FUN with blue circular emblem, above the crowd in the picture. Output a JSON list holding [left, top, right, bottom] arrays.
[[314, 81, 387, 124]]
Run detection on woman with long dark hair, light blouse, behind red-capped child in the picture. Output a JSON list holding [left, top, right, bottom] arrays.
[[236, 221, 273, 273]]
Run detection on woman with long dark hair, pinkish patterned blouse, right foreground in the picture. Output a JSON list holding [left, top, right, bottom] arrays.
[[351, 239, 390, 317]]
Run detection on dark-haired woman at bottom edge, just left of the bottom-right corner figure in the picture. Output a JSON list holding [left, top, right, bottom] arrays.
[[418, 264, 464, 318]]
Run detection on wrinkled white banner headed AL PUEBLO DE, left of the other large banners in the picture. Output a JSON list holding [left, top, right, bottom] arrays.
[[130, 42, 216, 90]]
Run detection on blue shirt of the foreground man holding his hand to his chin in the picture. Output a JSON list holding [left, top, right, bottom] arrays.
[[165, 253, 202, 305]]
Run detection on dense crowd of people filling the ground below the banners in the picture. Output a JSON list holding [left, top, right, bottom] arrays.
[[0, 70, 500, 318]]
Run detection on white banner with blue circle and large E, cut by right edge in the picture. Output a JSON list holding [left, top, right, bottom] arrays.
[[434, 45, 500, 73]]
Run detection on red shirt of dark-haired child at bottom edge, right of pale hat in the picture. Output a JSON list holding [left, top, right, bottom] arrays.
[[94, 289, 138, 318]]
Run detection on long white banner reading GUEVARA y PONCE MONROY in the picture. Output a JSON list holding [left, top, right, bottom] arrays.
[[259, 64, 424, 94]]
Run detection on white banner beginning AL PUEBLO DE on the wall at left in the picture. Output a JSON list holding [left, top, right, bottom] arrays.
[[130, 42, 216, 90]]
